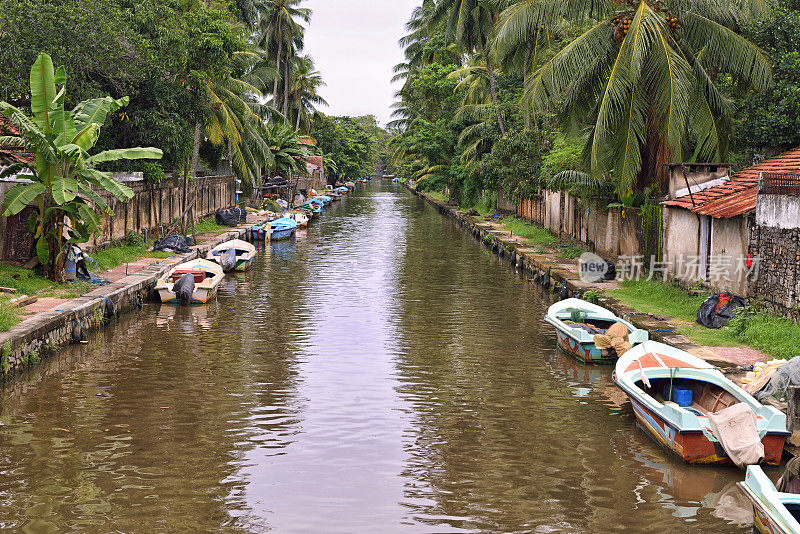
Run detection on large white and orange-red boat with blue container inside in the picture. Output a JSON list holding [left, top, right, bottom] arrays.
[[612, 341, 790, 465]]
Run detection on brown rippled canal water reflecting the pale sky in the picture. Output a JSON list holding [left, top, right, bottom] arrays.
[[0, 182, 751, 533]]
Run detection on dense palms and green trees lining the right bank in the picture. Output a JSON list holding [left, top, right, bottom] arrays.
[[392, 0, 800, 208]]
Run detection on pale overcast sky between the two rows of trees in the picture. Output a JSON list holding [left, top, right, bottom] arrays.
[[302, 0, 419, 124]]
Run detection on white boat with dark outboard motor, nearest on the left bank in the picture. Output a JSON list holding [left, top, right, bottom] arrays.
[[155, 258, 225, 306]]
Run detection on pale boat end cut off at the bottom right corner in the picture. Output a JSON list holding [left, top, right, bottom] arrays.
[[737, 465, 800, 534]]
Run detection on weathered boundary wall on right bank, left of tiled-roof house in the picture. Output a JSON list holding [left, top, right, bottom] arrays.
[[497, 191, 657, 261]]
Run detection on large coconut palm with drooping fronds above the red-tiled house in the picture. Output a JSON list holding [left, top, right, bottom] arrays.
[[497, 0, 771, 196]]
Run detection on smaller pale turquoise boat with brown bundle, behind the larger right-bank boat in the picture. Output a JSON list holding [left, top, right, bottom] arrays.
[[544, 298, 648, 364]]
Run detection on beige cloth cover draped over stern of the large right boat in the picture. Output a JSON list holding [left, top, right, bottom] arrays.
[[708, 402, 764, 469]]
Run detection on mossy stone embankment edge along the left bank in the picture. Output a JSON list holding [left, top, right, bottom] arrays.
[[0, 224, 253, 380]]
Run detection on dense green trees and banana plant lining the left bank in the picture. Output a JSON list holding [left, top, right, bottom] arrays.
[[0, 0, 390, 280]]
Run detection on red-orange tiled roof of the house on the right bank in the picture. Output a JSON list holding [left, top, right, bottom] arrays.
[[663, 148, 800, 219]]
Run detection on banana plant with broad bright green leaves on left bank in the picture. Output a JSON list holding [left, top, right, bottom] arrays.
[[0, 53, 162, 280]]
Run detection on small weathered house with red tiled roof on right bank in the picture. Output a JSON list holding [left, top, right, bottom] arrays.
[[662, 148, 800, 295]]
